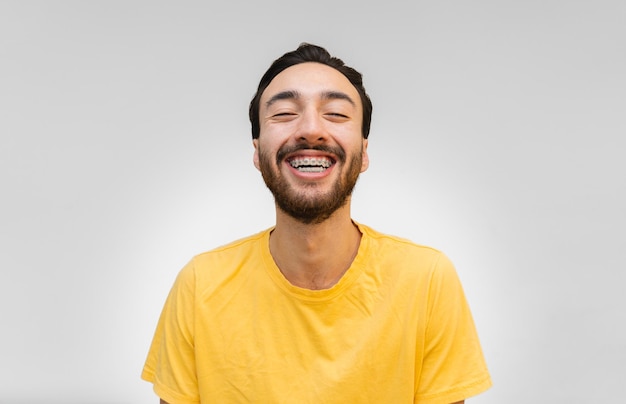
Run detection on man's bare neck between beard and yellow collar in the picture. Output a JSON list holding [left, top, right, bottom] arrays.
[[270, 204, 361, 289]]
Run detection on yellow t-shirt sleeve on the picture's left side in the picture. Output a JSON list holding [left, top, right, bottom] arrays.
[[141, 261, 200, 404]]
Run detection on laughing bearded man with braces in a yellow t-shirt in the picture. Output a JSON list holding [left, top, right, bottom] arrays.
[[142, 44, 491, 404]]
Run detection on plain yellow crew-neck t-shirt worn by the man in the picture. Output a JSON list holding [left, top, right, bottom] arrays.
[[142, 225, 491, 404]]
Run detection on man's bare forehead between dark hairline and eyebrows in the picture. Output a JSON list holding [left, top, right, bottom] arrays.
[[261, 62, 361, 108]]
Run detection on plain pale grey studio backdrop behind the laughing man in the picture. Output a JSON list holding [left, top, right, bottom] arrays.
[[0, 0, 626, 404]]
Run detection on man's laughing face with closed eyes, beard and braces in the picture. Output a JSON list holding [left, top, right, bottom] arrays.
[[253, 63, 369, 223]]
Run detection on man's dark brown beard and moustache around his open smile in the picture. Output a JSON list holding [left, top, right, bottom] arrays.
[[259, 144, 362, 224]]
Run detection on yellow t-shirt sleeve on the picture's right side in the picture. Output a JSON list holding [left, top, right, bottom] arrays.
[[415, 254, 491, 404]]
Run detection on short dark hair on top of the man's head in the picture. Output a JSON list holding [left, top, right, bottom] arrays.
[[249, 43, 372, 139]]
